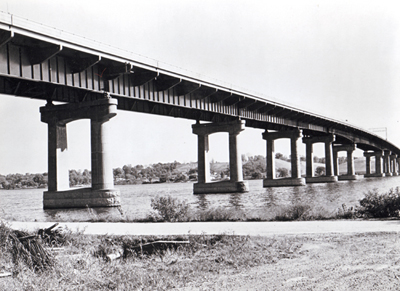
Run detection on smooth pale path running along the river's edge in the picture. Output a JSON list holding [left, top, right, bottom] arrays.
[[10, 220, 400, 236]]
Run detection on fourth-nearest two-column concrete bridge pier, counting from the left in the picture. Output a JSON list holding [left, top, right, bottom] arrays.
[[303, 134, 338, 183]]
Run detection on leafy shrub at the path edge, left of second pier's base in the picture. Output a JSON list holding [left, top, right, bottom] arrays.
[[151, 196, 190, 222]]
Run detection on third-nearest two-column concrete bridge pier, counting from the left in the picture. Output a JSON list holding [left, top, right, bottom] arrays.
[[263, 129, 306, 187]]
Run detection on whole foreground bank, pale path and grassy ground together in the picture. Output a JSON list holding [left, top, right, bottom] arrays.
[[0, 220, 400, 291]]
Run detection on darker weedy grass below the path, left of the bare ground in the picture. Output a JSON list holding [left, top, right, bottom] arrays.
[[0, 224, 300, 290]]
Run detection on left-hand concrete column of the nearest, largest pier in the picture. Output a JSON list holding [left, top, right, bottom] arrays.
[[47, 120, 69, 191]]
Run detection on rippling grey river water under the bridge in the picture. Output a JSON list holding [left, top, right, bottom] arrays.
[[0, 176, 400, 222]]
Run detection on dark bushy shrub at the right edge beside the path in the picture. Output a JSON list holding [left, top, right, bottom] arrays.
[[358, 187, 400, 218]]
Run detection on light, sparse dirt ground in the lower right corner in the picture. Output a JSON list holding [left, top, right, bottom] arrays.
[[179, 233, 400, 290]]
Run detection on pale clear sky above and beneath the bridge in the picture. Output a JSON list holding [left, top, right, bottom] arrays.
[[0, 0, 400, 174]]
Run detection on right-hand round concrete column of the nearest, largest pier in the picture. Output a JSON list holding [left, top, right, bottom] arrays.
[[91, 119, 114, 190]]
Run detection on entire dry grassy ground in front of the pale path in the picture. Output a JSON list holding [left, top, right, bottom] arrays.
[[0, 222, 400, 290]]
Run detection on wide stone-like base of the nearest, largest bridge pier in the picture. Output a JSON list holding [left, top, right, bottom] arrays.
[[43, 188, 121, 209]]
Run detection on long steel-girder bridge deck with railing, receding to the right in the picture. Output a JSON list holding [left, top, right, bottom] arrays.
[[0, 13, 400, 154]]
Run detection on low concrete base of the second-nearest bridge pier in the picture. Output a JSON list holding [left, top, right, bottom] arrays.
[[193, 181, 249, 194]]
